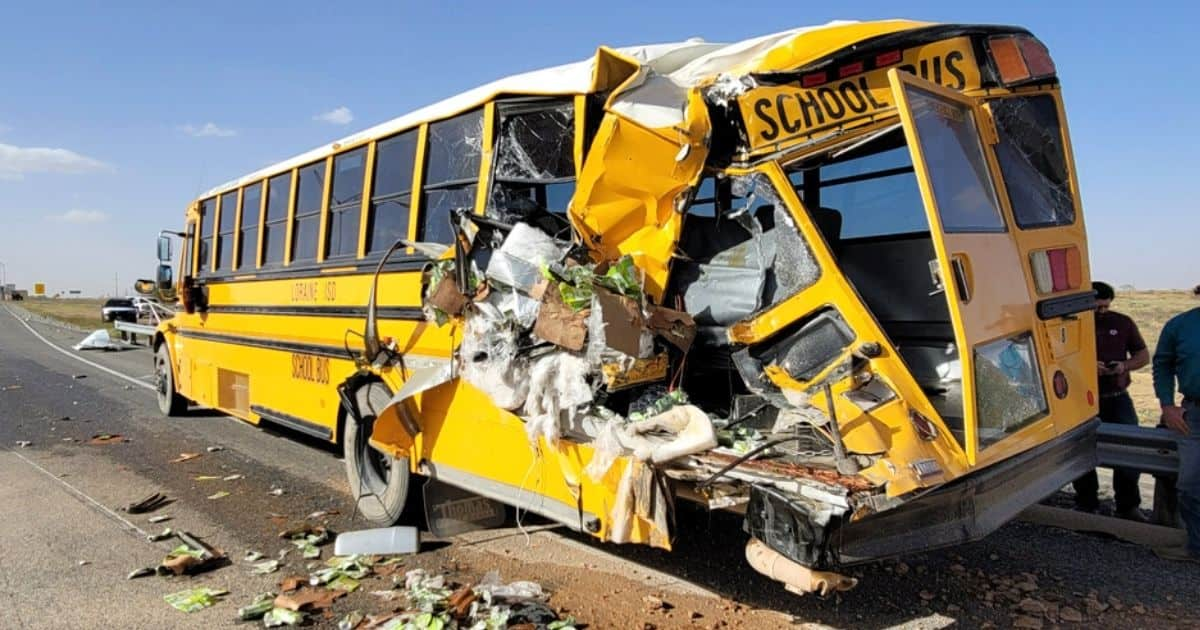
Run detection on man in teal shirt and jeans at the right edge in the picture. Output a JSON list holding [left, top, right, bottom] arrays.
[[1154, 286, 1200, 562]]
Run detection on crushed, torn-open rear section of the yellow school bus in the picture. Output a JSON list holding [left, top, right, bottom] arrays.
[[350, 20, 1096, 592]]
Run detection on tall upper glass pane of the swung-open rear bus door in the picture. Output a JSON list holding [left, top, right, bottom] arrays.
[[905, 85, 1004, 233]]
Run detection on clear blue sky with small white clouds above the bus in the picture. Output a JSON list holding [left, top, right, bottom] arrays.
[[0, 0, 1200, 294]]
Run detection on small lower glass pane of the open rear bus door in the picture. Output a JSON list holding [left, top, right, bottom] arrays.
[[974, 332, 1046, 448]]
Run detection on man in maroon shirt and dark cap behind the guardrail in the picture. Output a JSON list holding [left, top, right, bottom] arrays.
[[1073, 282, 1150, 521]]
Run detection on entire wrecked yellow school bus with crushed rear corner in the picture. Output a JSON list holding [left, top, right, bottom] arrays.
[[155, 20, 1097, 592]]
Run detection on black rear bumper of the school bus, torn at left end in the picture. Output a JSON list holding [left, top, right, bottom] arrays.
[[746, 419, 1099, 569]]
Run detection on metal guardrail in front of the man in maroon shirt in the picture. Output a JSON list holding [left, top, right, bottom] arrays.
[[1096, 422, 1180, 527]]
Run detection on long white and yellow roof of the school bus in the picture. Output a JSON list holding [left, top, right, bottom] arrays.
[[199, 19, 928, 198]]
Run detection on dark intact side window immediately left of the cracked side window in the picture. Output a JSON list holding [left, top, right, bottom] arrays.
[[416, 109, 484, 245]]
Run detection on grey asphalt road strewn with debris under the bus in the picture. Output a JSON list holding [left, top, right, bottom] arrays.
[[0, 302, 1200, 628]]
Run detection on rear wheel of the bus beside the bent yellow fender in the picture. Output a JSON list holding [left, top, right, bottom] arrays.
[[342, 383, 410, 526]]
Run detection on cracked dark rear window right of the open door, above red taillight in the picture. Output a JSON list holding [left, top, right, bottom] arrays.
[[990, 95, 1075, 228]]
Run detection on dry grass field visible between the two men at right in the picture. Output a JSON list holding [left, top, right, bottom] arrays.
[[1112, 290, 1200, 426]]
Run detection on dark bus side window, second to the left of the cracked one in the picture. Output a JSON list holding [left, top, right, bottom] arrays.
[[367, 130, 418, 254]]
